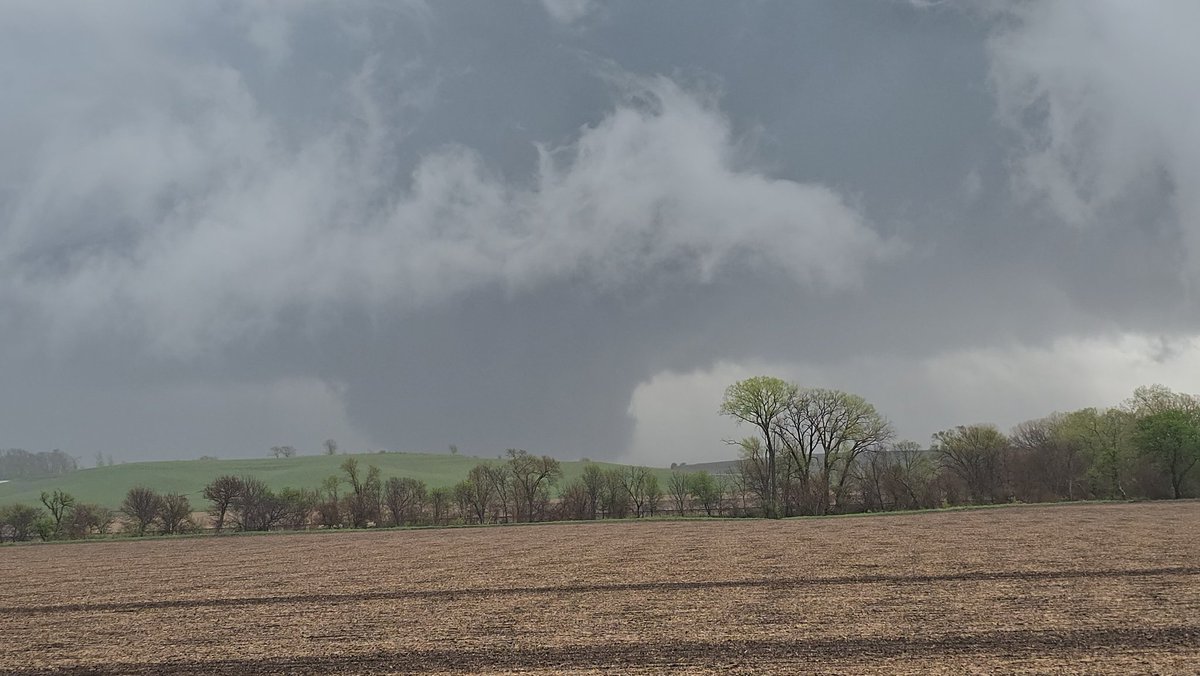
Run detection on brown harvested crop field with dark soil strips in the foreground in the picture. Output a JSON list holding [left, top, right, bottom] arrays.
[[0, 502, 1200, 674]]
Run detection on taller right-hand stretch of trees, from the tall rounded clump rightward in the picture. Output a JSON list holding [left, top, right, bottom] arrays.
[[720, 376, 1200, 516]]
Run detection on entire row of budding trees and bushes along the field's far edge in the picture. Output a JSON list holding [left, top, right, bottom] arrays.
[[0, 377, 1200, 540]]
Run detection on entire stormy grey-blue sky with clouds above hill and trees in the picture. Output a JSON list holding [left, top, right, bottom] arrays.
[[0, 0, 1200, 465]]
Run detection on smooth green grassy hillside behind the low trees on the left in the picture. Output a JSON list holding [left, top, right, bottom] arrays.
[[0, 453, 698, 508]]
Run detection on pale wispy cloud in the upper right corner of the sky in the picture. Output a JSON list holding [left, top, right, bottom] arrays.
[[989, 0, 1200, 271]]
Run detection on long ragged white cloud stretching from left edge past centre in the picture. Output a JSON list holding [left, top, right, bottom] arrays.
[[0, 52, 898, 354]]
